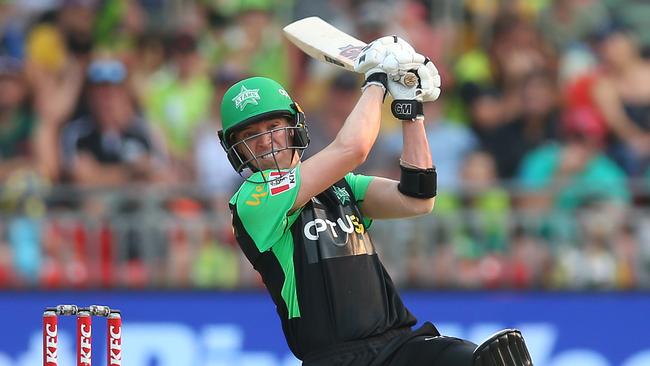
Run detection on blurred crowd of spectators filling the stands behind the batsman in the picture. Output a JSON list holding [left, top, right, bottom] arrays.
[[0, 0, 650, 289]]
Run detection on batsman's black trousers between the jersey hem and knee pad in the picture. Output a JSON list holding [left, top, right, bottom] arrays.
[[303, 323, 476, 366]]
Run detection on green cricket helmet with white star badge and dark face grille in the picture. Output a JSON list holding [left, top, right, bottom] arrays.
[[218, 77, 309, 175]]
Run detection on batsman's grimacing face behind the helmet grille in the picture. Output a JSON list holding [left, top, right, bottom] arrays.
[[235, 118, 294, 170]]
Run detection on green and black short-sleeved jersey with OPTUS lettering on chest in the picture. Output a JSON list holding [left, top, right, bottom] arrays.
[[230, 166, 416, 359]]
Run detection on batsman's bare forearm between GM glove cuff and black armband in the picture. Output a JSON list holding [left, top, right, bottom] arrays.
[[401, 119, 433, 169]]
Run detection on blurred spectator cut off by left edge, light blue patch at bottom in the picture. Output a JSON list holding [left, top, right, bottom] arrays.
[[0, 56, 51, 284]]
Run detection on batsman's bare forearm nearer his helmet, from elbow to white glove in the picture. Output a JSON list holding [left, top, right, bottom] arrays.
[[334, 85, 384, 161]]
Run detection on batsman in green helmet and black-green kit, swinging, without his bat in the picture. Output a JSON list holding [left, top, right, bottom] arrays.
[[219, 36, 532, 366]]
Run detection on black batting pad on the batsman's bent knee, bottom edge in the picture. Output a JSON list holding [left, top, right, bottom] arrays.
[[472, 329, 533, 366]]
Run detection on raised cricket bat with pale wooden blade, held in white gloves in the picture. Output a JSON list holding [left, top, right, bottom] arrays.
[[283, 17, 418, 86]]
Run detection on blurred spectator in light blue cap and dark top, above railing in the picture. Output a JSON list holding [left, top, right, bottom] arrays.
[[61, 59, 160, 186]]
